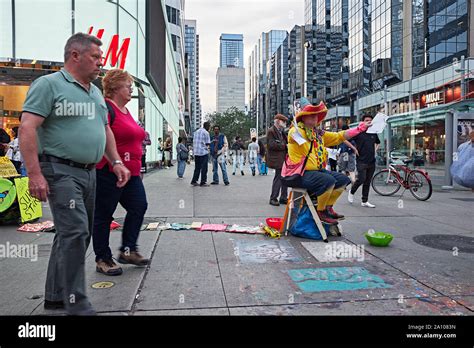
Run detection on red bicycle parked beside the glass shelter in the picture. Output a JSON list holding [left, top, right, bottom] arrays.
[[371, 156, 433, 201]]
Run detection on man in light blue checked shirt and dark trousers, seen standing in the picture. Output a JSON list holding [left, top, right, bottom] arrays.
[[191, 122, 211, 186]]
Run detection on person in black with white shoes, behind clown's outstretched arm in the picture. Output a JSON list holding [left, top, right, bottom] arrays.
[[347, 115, 380, 208]]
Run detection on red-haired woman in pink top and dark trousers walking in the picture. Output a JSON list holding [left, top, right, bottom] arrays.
[[92, 69, 149, 275]]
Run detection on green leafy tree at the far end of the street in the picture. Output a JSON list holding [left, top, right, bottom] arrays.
[[207, 107, 256, 144]]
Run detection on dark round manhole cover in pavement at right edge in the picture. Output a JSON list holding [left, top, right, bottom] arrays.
[[413, 234, 474, 254]]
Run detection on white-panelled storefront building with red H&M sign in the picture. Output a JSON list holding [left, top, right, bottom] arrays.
[[0, 0, 181, 163]]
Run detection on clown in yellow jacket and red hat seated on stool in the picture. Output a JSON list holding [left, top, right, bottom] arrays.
[[288, 98, 371, 225]]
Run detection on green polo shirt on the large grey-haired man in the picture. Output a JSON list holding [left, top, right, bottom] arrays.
[[23, 69, 107, 163]]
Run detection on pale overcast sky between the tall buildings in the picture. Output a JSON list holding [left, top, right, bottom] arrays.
[[185, 0, 304, 115]]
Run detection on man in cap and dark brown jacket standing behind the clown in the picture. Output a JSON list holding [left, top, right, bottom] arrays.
[[267, 114, 288, 206]]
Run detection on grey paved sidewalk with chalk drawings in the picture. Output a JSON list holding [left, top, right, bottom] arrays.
[[0, 166, 474, 315]]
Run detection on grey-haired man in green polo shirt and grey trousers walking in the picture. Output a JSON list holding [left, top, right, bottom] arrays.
[[20, 33, 130, 315]]
